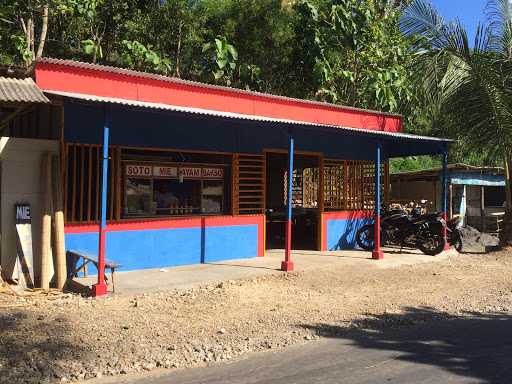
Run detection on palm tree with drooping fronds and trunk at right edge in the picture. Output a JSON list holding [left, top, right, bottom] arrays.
[[401, 0, 512, 244]]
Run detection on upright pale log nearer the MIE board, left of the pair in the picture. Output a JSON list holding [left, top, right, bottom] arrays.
[[40, 153, 52, 290]]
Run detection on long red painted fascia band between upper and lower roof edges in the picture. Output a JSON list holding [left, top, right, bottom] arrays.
[[35, 62, 402, 132]]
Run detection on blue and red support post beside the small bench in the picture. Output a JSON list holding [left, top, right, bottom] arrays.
[[92, 106, 111, 297]]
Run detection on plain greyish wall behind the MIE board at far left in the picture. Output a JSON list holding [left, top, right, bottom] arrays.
[[0, 137, 59, 279]]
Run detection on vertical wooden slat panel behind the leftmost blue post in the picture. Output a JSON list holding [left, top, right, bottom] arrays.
[[63, 144, 121, 224]]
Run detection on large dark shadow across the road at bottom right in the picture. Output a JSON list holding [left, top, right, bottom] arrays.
[[302, 308, 512, 384]]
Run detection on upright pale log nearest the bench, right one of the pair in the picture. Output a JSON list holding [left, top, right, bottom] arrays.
[[52, 156, 67, 290]]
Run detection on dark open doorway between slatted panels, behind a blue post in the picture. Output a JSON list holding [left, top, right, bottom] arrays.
[[265, 152, 320, 250]]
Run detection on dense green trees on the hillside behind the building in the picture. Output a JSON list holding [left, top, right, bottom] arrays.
[[0, 0, 510, 170]]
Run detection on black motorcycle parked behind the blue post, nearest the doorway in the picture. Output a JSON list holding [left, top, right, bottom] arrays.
[[356, 202, 446, 256]]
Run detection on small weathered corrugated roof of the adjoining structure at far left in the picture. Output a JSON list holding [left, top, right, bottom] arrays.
[[0, 77, 50, 103]]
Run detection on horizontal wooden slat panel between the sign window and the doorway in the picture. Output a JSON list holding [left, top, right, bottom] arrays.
[[232, 153, 266, 215]]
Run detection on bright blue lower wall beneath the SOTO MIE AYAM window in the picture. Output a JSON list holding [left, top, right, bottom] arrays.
[[66, 225, 258, 274]]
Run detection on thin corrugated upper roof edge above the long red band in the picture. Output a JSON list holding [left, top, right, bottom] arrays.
[[37, 57, 402, 118]]
